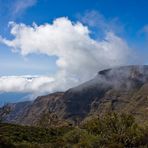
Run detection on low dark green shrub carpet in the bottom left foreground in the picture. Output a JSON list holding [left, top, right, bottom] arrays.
[[0, 123, 71, 144]]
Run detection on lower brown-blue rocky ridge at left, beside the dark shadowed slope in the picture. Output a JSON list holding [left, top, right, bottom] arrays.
[[1, 92, 63, 125]]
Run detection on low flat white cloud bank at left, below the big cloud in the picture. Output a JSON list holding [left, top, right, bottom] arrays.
[[0, 76, 54, 93]]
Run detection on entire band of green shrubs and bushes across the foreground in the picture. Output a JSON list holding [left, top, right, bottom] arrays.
[[0, 113, 148, 148]]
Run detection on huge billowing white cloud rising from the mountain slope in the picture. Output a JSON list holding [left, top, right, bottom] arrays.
[[0, 17, 130, 91]]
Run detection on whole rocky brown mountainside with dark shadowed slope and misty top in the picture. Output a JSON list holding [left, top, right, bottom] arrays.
[[1, 66, 148, 125]]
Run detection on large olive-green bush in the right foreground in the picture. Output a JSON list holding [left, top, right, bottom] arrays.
[[82, 113, 144, 147]]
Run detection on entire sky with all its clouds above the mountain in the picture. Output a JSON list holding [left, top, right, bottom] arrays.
[[0, 0, 148, 102]]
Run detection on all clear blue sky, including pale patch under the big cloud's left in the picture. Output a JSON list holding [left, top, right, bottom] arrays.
[[0, 0, 148, 75]]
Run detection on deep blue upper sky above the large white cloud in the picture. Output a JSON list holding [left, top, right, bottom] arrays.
[[0, 0, 148, 40]]
